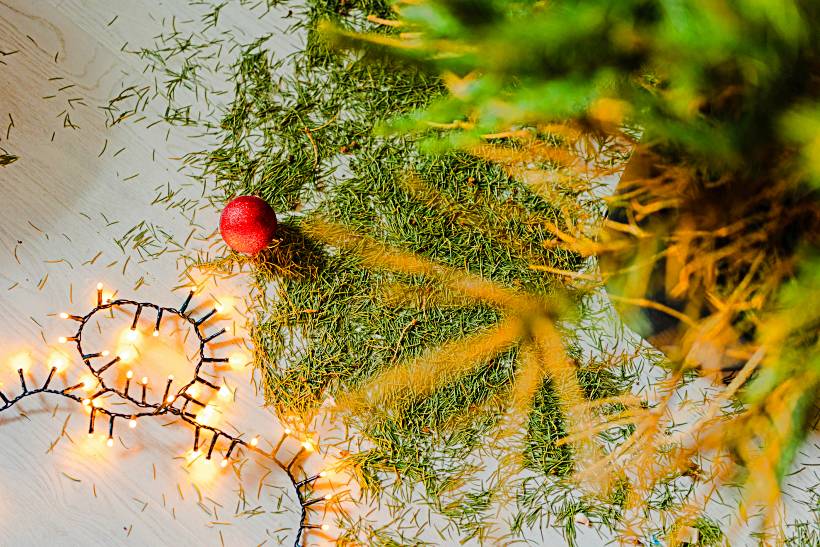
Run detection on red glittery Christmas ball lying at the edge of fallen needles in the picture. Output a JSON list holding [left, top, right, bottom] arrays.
[[219, 196, 276, 255]]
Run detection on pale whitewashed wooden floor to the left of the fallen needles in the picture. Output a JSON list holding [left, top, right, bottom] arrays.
[[0, 0, 335, 546]]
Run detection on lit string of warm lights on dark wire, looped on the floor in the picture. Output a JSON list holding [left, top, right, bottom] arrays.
[[0, 283, 333, 547]]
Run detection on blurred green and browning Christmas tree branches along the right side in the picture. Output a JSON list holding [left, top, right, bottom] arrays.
[[327, 0, 820, 541]]
